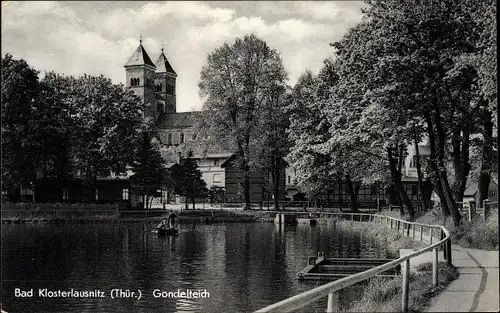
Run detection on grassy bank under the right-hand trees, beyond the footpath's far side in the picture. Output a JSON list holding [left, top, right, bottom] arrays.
[[383, 209, 499, 251]]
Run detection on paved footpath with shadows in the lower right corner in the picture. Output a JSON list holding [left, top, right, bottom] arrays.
[[427, 245, 500, 312]]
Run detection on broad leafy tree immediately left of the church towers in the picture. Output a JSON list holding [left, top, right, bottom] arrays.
[[65, 75, 146, 180]]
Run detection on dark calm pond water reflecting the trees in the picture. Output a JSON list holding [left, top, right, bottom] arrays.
[[2, 223, 392, 313]]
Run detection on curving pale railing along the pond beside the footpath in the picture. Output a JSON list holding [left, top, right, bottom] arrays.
[[255, 213, 451, 313]]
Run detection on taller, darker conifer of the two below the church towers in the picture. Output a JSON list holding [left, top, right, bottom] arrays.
[[130, 132, 168, 210]]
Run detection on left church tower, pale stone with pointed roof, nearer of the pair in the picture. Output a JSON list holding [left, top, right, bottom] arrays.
[[125, 38, 158, 120]]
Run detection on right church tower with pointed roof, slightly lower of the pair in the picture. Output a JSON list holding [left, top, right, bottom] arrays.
[[155, 47, 177, 113]]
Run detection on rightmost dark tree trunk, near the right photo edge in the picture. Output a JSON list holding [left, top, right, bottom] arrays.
[[476, 109, 494, 208]]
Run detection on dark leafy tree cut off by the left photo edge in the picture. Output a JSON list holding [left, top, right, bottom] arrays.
[[2, 54, 40, 196]]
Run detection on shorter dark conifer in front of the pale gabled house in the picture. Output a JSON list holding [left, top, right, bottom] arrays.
[[174, 151, 208, 210]]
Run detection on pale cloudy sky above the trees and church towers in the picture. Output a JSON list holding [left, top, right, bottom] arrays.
[[2, 1, 363, 112]]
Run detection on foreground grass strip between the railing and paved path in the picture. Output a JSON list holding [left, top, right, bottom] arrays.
[[343, 262, 459, 312]]
